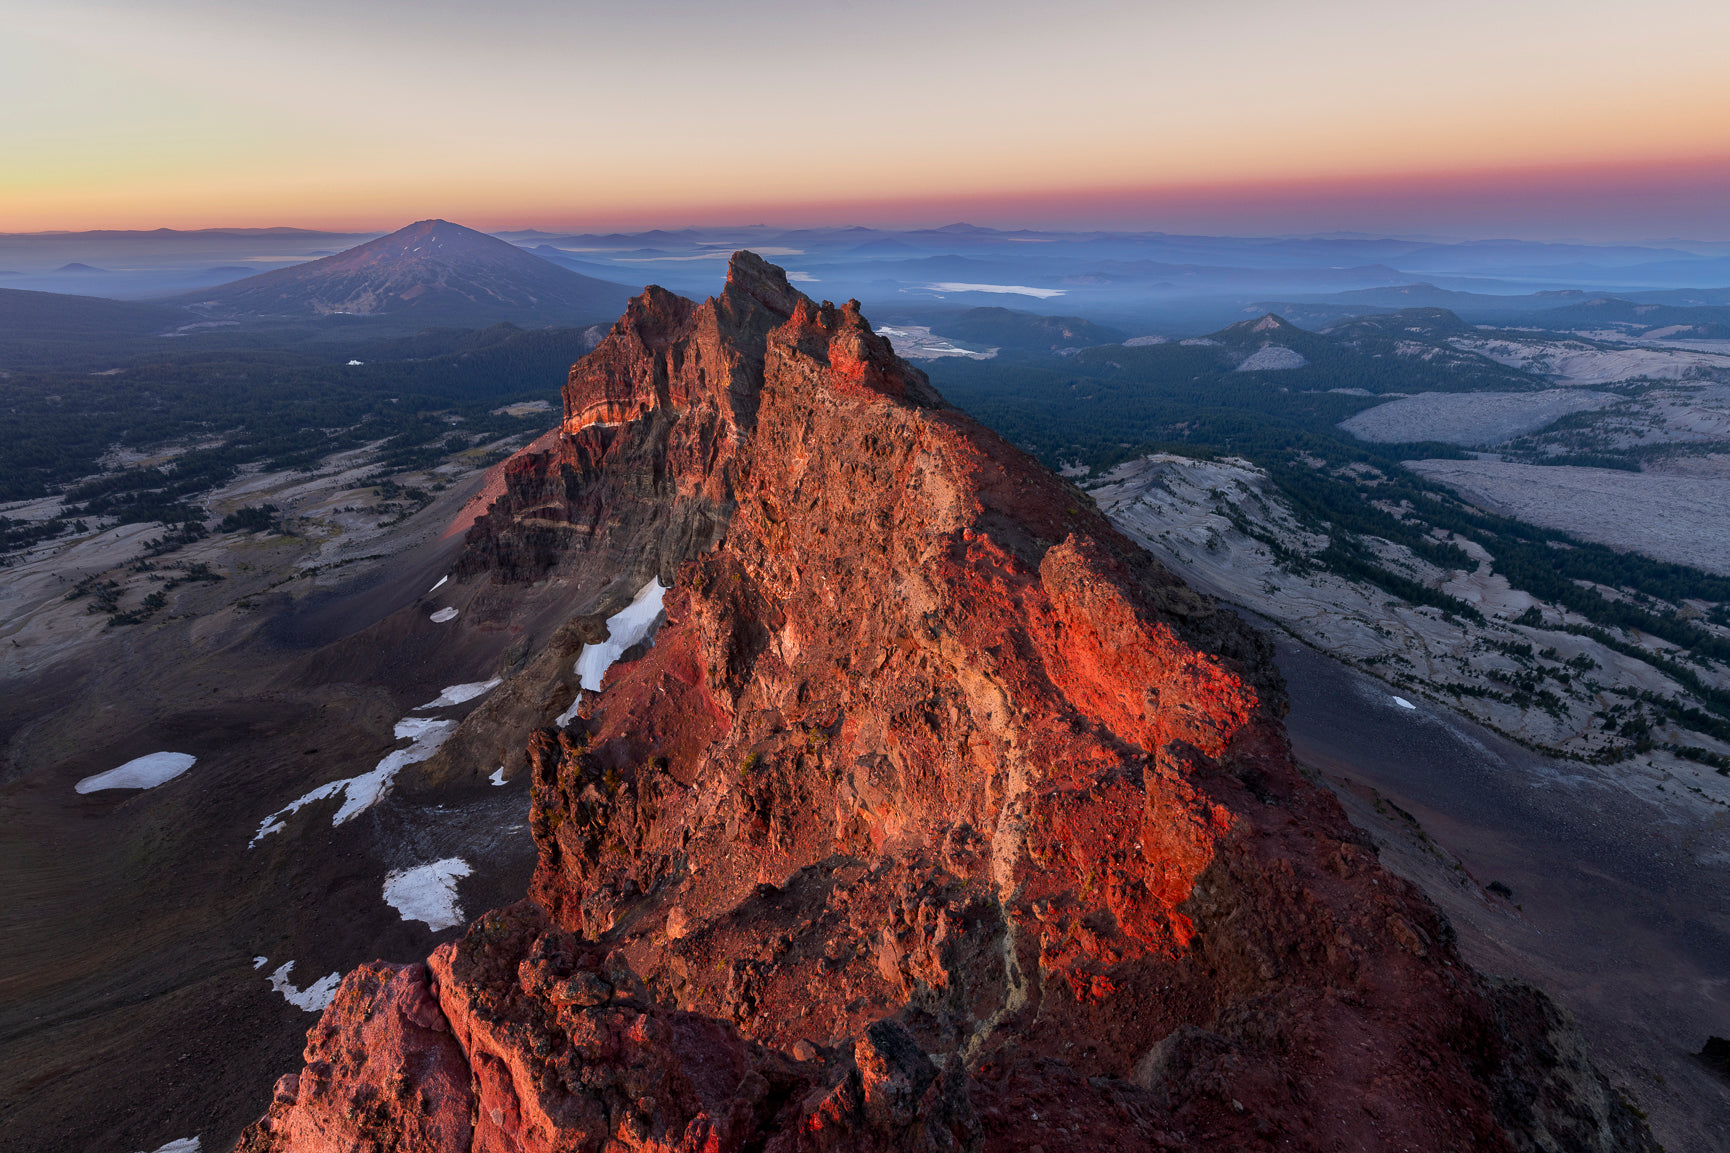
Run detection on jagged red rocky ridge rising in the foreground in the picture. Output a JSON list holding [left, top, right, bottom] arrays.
[[246, 253, 1652, 1153]]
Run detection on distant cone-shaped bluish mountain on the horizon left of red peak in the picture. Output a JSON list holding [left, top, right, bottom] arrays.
[[182, 220, 631, 325]]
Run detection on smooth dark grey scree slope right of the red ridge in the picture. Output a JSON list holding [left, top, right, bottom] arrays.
[[1275, 634, 1730, 1153]]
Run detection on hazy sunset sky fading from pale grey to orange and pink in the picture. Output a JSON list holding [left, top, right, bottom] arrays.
[[0, 0, 1730, 239]]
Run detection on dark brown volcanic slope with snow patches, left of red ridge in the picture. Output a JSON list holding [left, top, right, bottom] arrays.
[[0, 490, 560, 1153]]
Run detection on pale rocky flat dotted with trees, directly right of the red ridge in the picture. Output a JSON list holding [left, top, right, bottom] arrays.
[[1090, 455, 1730, 806]]
